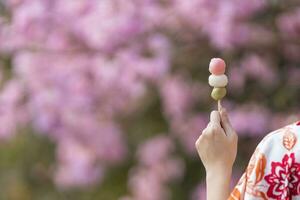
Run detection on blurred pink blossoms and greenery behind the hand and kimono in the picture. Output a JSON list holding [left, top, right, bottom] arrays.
[[0, 0, 300, 200]]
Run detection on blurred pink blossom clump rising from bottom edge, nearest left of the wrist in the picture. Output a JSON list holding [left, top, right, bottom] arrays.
[[122, 135, 184, 200]]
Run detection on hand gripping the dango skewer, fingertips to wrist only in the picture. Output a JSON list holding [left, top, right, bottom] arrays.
[[196, 108, 238, 173]]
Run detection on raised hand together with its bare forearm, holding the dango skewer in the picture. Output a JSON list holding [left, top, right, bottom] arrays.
[[196, 108, 238, 200]]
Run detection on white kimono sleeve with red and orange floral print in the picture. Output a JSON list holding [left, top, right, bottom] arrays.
[[228, 122, 300, 200]]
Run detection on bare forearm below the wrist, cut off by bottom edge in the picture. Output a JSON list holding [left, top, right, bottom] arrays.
[[206, 169, 232, 200]]
